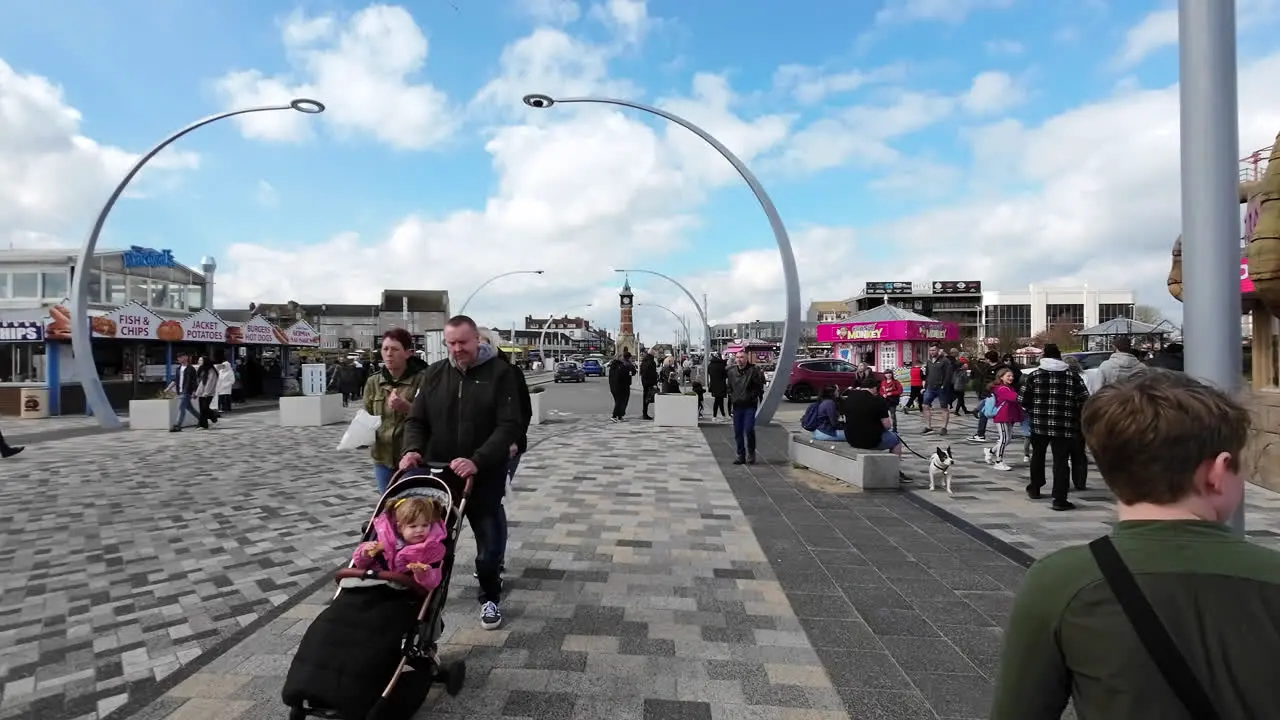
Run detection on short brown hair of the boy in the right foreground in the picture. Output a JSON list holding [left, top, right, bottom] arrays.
[[1080, 368, 1252, 505]]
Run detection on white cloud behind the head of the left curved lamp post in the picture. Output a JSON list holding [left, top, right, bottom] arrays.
[[216, 5, 457, 150]]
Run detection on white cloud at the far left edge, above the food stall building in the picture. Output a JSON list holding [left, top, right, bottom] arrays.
[[0, 59, 200, 247]]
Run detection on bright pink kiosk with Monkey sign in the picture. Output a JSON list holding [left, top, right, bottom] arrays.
[[818, 305, 960, 370]]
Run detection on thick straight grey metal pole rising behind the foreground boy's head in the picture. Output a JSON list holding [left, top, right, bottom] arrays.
[[1178, 0, 1244, 534]]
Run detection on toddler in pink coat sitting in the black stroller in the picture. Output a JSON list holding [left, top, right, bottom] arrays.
[[352, 497, 447, 591]]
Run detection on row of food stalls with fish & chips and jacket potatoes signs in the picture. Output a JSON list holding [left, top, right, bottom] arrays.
[[0, 301, 320, 415]]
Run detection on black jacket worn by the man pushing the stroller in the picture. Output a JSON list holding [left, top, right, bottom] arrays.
[[401, 346, 525, 507]]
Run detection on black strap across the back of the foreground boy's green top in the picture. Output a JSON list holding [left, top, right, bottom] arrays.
[[1089, 536, 1221, 720]]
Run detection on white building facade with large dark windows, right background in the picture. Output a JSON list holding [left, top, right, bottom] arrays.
[[982, 284, 1135, 340]]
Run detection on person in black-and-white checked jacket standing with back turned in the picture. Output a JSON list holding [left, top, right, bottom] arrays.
[[1018, 343, 1089, 510]]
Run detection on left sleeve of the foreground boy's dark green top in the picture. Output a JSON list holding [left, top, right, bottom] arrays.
[[991, 562, 1075, 720]]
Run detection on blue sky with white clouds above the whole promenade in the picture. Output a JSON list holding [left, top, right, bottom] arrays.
[[0, 0, 1280, 337]]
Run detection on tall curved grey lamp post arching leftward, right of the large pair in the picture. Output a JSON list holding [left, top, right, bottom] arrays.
[[524, 94, 801, 423]]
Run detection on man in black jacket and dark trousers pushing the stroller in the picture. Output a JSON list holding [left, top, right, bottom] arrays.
[[399, 315, 525, 630]]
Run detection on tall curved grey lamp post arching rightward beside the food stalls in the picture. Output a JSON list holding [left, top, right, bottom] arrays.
[[72, 97, 325, 430]]
